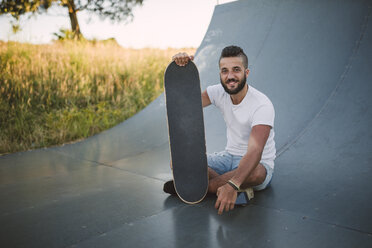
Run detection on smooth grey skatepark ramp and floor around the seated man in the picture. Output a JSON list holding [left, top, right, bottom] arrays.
[[0, 0, 372, 248]]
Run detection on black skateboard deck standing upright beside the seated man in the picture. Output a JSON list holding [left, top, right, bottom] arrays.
[[164, 61, 208, 204]]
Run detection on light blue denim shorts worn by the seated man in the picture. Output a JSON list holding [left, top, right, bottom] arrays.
[[207, 151, 274, 191]]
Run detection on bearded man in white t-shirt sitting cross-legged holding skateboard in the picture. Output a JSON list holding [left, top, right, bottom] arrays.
[[164, 46, 276, 214]]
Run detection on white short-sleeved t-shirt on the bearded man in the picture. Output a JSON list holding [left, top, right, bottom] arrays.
[[207, 84, 276, 168]]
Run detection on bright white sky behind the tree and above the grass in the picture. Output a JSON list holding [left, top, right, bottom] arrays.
[[0, 0, 232, 48]]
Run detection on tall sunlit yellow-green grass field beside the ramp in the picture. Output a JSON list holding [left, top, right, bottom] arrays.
[[0, 42, 195, 154]]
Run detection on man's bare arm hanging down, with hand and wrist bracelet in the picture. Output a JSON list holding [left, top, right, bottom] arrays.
[[215, 125, 271, 214]]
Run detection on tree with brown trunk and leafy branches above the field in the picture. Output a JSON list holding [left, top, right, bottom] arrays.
[[0, 0, 143, 39]]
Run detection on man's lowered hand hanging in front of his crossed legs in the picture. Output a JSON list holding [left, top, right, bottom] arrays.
[[214, 184, 238, 214]]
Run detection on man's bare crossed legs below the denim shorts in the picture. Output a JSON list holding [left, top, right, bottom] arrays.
[[208, 164, 266, 194]]
